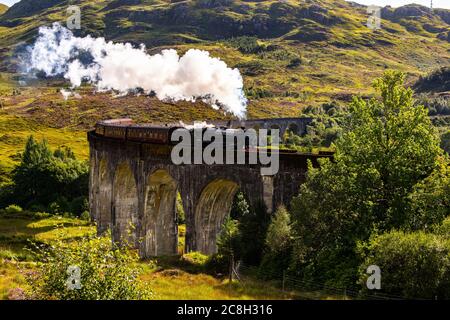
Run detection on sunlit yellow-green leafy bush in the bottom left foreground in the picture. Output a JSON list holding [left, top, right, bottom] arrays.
[[26, 235, 151, 300]]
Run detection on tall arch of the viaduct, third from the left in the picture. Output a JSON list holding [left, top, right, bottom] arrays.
[[140, 169, 178, 257]]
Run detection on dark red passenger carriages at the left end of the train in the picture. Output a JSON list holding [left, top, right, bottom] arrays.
[[95, 119, 182, 144]]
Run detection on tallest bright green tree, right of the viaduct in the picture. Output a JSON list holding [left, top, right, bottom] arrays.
[[335, 71, 441, 229]]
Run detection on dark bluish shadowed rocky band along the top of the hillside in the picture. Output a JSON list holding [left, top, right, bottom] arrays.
[[105, 0, 341, 40]]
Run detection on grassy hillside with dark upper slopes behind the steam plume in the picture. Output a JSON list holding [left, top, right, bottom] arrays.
[[0, 0, 450, 128]]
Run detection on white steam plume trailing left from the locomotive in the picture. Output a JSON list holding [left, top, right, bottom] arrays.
[[27, 23, 247, 118]]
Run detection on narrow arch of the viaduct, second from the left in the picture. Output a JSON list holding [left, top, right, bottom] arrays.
[[111, 162, 139, 244]]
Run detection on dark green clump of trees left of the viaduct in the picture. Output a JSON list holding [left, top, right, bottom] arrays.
[[3, 136, 89, 215]]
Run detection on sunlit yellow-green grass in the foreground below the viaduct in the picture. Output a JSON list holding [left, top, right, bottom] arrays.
[[0, 216, 340, 300]]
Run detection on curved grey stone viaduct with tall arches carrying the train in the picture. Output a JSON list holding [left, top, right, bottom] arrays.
[[88, 119, 330, 257]]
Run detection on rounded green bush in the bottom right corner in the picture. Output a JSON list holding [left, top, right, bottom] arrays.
[[358, 231, 450, 299]]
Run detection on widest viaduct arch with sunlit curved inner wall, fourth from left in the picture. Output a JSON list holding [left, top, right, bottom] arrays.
[[195, 179, 239, 255]]
